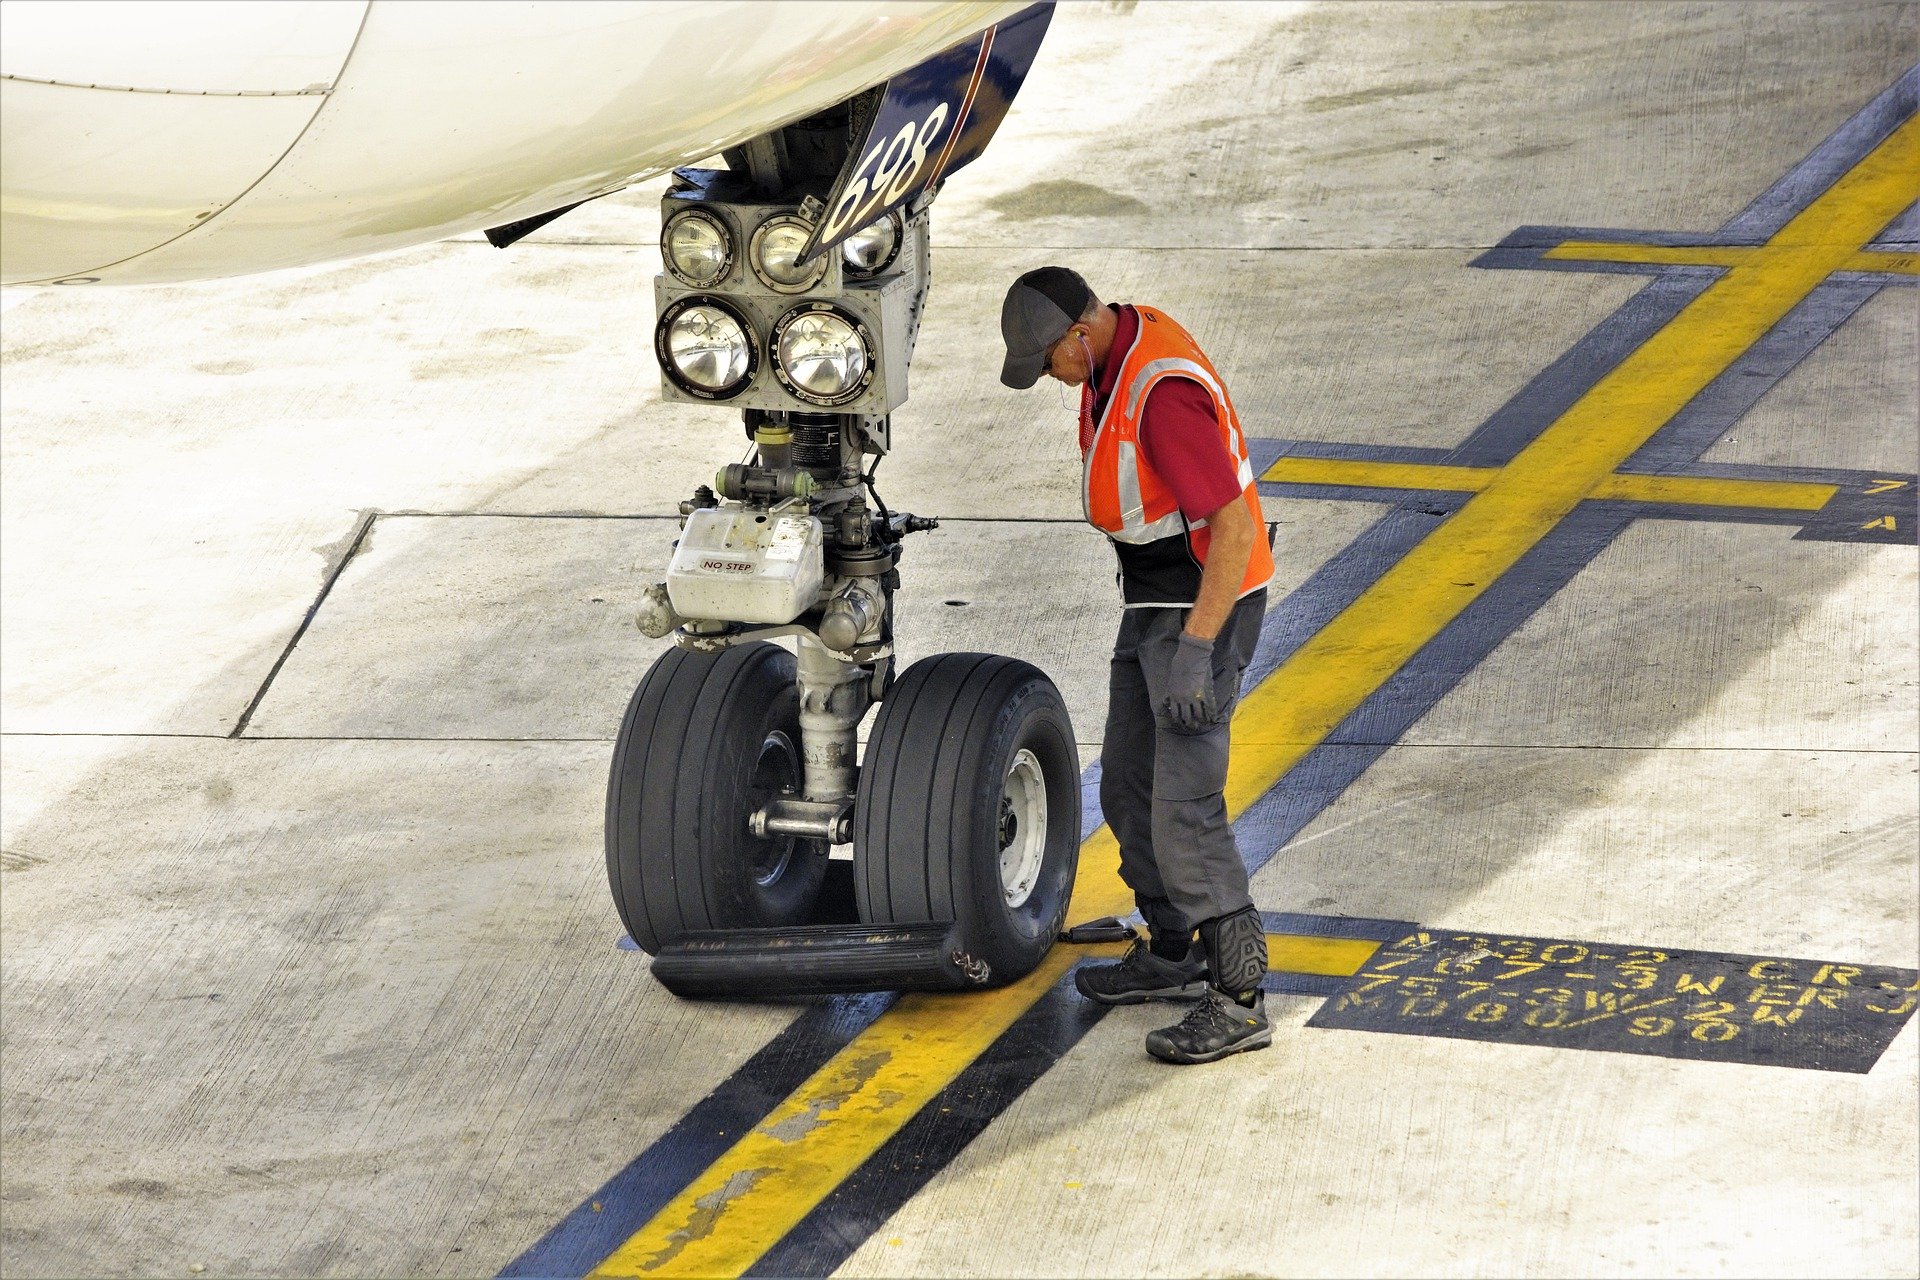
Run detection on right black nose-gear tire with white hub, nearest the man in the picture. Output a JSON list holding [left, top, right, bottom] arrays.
[[852, 652, 1081, 986]]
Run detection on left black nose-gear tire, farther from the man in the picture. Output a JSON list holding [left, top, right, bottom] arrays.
[[607, 643, 828, 956]]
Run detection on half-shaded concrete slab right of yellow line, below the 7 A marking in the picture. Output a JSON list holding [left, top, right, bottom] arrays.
[[1405, 520, 1920, 750]]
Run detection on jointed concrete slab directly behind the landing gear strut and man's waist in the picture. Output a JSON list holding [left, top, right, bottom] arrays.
[[248, 503, 1371, 747]]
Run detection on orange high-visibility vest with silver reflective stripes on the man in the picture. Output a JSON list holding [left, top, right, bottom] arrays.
[[1081, 307, 1273, 597]]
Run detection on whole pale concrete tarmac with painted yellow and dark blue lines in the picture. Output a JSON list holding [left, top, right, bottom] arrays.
[[0, 2, 1920, 1276]]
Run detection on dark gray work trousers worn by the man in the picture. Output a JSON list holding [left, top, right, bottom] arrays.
[[1100, 591, 1267, 936]]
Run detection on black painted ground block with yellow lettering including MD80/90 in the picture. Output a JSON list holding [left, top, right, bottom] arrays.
[[1308, 929, 1920, 1075]]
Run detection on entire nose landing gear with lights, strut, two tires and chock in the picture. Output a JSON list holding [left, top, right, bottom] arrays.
[[607, 97, 1079, 996]]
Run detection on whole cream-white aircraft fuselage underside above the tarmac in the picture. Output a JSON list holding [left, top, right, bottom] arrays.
[[0, 0, 1023, 284]]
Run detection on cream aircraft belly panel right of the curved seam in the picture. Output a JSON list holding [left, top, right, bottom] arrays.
[[6, 0, 1021, 284]]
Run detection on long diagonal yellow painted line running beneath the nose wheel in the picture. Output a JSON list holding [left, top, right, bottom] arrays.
[[593, 119, 1920, 1276]]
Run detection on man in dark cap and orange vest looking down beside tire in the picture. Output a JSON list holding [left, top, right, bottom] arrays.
[[1000, 267, 1273, 1063]]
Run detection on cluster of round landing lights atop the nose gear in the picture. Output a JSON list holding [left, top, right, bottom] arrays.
[[655, 203, 906, 409]]
